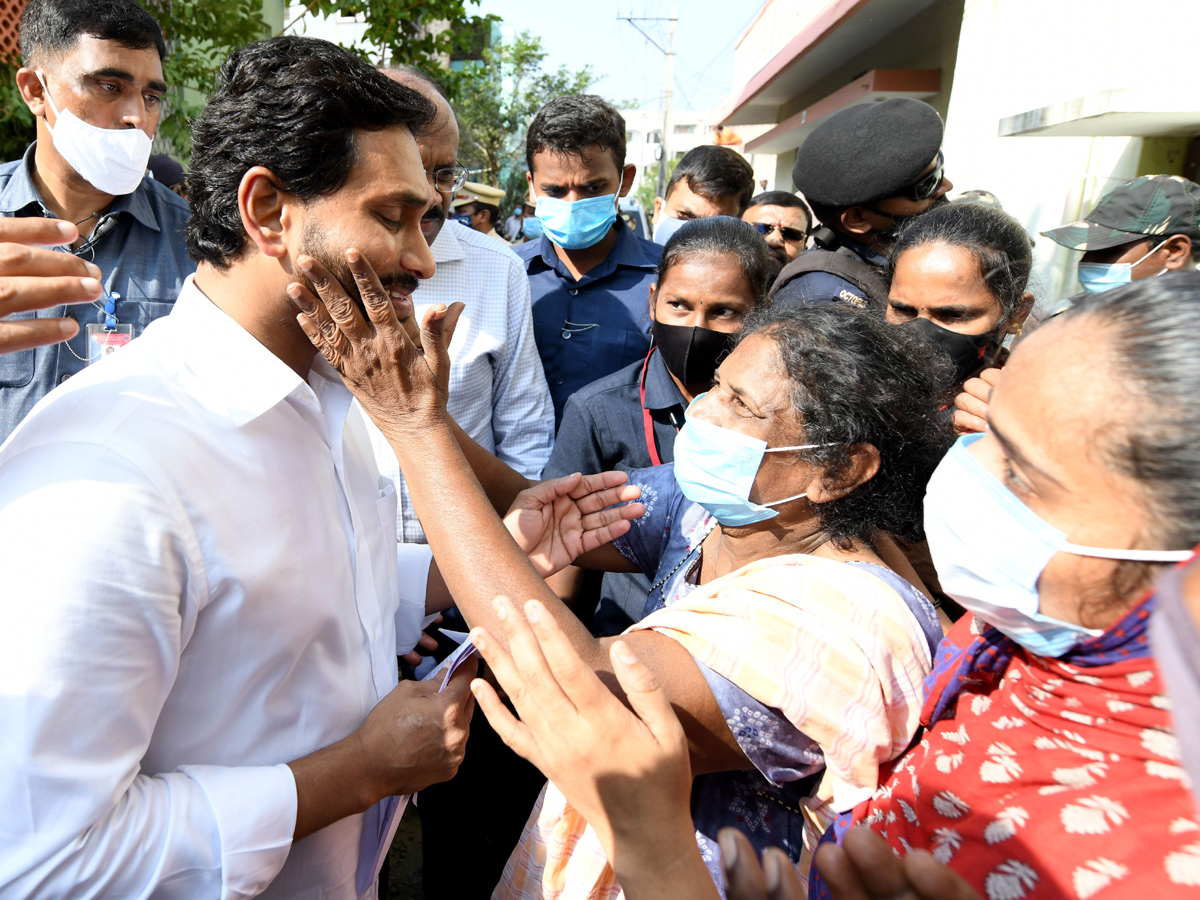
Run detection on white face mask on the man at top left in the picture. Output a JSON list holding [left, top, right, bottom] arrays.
[[36, 72, 150, 197]]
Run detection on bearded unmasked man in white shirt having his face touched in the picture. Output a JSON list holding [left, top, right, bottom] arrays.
[[0, 36, 473, 900]]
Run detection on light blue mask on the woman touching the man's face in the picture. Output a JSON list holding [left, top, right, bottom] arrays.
[[674, 394, 824, 527]]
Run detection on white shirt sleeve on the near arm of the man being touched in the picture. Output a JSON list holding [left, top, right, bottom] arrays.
[[0, 444, 296, 900]]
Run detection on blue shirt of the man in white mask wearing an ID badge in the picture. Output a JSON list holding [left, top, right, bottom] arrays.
[[0, 142, 196, 440]]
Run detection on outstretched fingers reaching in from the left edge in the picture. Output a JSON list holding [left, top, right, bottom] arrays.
[[0, 218, 101, 354]]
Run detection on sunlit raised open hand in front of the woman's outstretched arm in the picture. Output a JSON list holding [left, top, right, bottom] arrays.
[[470, 598, 698, 876]]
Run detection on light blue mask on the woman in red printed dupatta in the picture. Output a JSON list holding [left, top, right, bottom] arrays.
[[925, 434, 1192, 656]]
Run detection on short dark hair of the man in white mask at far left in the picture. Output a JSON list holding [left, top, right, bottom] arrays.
[[18, 0, 167, 66]]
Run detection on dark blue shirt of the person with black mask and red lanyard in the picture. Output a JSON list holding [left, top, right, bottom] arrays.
[[542, 352, 688, 637]]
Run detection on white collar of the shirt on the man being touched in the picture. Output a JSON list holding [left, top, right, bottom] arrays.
[[169, 275, 326, 428]]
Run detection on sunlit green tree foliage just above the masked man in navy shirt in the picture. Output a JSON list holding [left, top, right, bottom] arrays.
[[455, 31, 595, 210]]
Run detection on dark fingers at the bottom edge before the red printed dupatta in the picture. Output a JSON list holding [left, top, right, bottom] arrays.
[[816, 827, 980, 900]]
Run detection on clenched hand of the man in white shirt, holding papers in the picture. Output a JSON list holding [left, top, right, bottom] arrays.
[[356, 660, 478, 797]]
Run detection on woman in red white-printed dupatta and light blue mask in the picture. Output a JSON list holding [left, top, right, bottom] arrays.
[[810, 274, 1200, 900]]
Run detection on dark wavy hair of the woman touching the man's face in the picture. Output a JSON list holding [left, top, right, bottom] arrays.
[[739, 304, 954, 547]]
